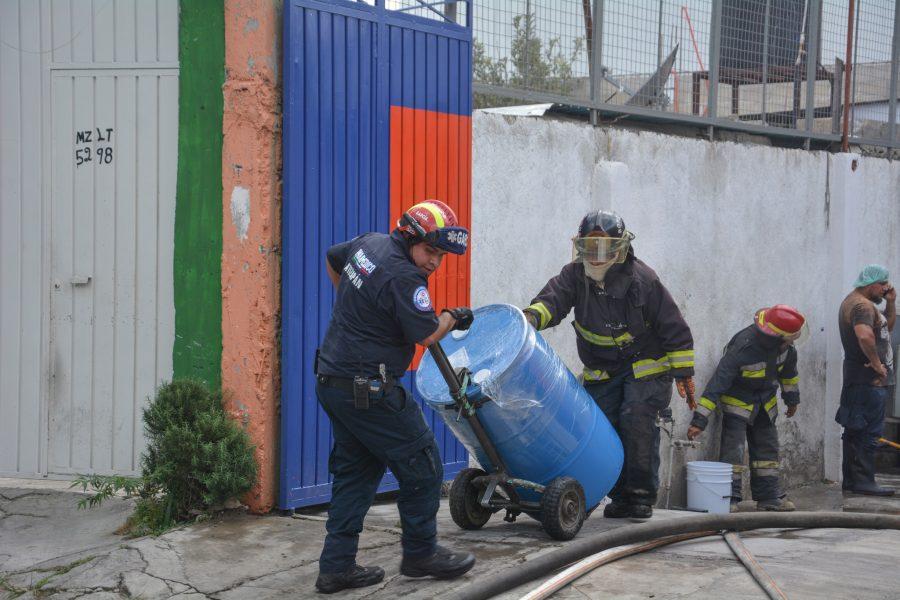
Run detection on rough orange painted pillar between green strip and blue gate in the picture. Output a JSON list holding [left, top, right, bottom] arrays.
[[222, 0, 281, 513]]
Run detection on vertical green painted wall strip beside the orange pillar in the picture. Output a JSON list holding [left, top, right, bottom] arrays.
[[173, 0, 225, 387]]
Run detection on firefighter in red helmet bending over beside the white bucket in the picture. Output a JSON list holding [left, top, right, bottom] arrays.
[[688, 304, 806, 512]]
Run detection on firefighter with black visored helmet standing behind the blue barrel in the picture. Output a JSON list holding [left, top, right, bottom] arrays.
[[524, 211, 694, 519]]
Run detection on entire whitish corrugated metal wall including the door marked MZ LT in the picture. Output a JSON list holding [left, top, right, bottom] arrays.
[[0, 0, 178, 475]]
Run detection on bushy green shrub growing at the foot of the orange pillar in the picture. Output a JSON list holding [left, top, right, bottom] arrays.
[[72, 379, 258, 536]]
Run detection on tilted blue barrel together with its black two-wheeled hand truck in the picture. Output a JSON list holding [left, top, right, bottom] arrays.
[[416, 304, 623, 539]]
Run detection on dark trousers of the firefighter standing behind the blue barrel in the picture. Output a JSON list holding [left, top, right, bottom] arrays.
[[585, 372, 672, 506]]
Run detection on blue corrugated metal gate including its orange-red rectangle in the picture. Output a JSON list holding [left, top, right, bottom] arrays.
[[279, 0, 471, 508]]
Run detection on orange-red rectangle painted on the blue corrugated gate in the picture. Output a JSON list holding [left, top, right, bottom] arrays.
[[390, 106, 472, 370]]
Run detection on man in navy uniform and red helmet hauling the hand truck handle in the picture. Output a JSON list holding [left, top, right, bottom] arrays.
[[316, 200, 475, 593]]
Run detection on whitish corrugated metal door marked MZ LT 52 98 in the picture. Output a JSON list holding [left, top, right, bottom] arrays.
[[48, 69, 178, 473]]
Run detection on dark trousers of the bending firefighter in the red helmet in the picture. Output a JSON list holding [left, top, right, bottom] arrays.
[[719, 410, 782, 501]]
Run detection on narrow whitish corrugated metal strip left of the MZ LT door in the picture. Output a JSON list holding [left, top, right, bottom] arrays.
[[0, 0, 48, 474]]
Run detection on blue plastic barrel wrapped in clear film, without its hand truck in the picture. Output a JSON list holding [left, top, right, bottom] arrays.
[[416, 304, 623, 507]]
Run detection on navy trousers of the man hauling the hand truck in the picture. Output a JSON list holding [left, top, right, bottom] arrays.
[[316, 383, 444, 573]]
